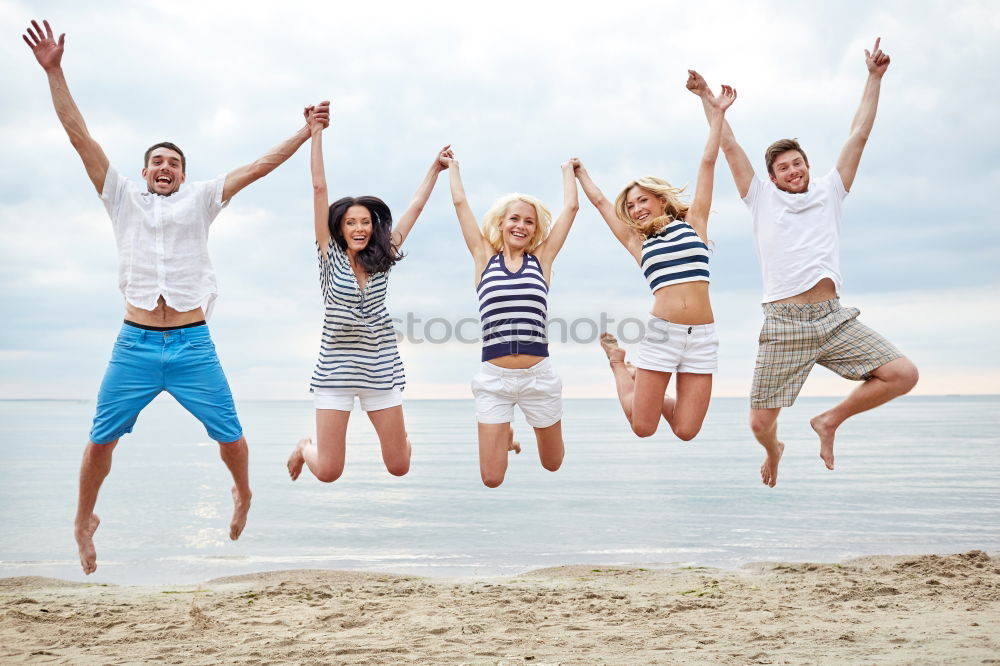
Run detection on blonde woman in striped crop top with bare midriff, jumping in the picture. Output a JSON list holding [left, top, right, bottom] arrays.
[[574, 79, 736, 441]]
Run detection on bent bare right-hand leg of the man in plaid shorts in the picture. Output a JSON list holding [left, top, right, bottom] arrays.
[[809, 358, 919, 469]]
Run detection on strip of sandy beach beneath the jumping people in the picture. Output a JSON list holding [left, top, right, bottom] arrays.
[[0, 551, 1000, 664]]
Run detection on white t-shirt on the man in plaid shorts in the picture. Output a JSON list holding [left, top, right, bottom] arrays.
[[743, 169, 847, 303]]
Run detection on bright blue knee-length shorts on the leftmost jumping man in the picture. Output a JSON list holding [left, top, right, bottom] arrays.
[[90, 324, 243, 444]]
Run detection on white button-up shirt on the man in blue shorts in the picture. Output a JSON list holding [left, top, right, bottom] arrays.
[[101, 166, 229, 318]]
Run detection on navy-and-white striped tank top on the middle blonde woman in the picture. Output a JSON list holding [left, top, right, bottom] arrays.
[[476, 252, 549, 361]]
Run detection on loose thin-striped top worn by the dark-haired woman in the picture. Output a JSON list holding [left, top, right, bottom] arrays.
[[310, 238, 406, 391]]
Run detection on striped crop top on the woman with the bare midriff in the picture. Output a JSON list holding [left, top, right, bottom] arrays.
[[642, 220, 709, 293]]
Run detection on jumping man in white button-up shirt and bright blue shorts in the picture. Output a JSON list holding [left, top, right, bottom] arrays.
[[23, 21, 329, 574]]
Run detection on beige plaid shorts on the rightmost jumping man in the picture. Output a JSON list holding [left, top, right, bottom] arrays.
[[750, 298, 903, 409]]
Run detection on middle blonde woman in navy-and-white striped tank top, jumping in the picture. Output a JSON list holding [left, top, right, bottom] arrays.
[[448, 152, 579, 488]]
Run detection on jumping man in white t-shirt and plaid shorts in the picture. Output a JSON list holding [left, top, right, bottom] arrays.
[[688, 39, 917, 487]]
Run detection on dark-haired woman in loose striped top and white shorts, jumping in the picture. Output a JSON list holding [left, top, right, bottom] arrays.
[[288, 109, 451, 482]]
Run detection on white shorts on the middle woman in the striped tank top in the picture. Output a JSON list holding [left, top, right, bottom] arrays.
[[472, 358, 562, 428]]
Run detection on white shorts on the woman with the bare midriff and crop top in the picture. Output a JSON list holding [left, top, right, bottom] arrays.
[[635, 317, 719, 375]]
